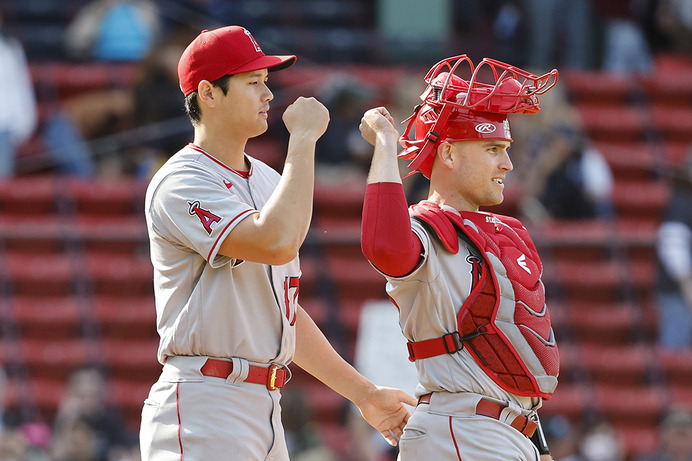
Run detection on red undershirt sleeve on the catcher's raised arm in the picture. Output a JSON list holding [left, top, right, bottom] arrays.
[[361, 182, 423, 277]]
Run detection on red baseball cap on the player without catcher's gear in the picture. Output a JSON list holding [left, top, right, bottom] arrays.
[[178, 26, 296, 96]]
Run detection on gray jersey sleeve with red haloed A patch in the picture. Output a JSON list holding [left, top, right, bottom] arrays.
[[149, 170, 258, 268]]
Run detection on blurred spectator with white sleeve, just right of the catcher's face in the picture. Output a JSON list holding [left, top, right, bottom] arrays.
[[503, 78, 613, 222]]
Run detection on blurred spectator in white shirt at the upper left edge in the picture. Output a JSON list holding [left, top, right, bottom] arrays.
[[0, 11, 38, 177]]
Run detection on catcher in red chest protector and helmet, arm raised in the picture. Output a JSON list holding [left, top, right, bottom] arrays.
[[360, 55, 559, 461]]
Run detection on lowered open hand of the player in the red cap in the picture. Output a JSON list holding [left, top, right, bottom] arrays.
[[355, 386, 417, 446]]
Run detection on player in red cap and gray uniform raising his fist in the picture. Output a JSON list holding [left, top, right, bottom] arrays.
[[140, 26, 415, 461]]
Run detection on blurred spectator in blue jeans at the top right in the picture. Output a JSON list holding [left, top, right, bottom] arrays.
[[594, 0, 653, 73]]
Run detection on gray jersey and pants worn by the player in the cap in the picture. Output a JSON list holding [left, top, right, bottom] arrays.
[[140, 144, 300, 460]]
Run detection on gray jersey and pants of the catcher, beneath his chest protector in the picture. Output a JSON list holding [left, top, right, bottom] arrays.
[[378, 210, 541, 461]]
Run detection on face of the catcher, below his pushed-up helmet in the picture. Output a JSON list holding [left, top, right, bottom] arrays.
[[451, 140, 513, 211]]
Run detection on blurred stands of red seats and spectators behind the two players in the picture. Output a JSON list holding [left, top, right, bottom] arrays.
[[0, 0, 692, 461]]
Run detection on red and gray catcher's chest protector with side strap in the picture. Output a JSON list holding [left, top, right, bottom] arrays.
[[408, 202, 560, 400]]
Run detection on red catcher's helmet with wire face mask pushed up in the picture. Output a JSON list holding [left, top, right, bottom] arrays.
[[399, 55, 558, 178]]
